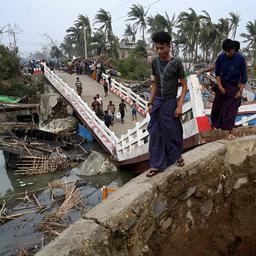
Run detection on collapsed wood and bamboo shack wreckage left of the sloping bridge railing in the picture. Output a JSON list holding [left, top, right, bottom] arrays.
[[0, 128, 85, 175]]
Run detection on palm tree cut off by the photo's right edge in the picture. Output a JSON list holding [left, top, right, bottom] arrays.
[[241, 20, 256, 68]]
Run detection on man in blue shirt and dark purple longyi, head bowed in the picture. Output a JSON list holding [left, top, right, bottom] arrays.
[[211, 39, 247, 139]]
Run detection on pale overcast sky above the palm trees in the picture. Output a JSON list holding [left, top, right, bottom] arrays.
[[0, 0, 256, 55]]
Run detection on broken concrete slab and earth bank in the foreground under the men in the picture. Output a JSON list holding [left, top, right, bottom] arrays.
[[36, 136, 256, 256]]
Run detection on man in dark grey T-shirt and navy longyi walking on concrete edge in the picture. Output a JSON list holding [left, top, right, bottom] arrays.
[[147, 31, 187, 177]]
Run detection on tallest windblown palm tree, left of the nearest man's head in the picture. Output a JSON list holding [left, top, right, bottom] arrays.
[[127, 4, 148, 43]]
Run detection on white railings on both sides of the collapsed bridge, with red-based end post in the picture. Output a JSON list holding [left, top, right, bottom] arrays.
[[44, 66, 256, 165]]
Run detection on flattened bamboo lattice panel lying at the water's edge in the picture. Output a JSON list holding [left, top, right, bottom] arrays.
[[15, 154, 67, 175]]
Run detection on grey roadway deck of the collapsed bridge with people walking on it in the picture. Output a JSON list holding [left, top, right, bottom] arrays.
[[56, 71, 144, 137]]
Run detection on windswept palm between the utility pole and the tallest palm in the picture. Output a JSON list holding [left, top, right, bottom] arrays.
[[94, 8, 114, 55]]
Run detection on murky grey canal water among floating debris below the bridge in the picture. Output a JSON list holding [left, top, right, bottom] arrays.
[[0, 147, 135, 256]]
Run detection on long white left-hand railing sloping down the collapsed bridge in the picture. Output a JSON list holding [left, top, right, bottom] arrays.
[[44, 66, 118, 154]]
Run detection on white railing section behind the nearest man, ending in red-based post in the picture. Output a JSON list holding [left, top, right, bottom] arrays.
[[117, 75, 214, 161]]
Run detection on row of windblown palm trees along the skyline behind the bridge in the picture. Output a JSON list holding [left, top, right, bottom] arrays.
[[61, 4, 256, 76]]
